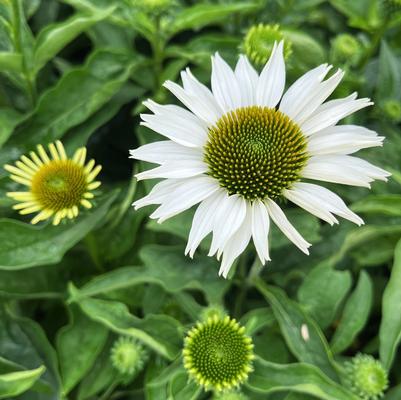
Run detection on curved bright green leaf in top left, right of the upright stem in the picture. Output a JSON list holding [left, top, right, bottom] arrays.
[[34, 7, 115, 73]]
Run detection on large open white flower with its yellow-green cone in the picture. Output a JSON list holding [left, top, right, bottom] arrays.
[[131, 42, 389, 277]]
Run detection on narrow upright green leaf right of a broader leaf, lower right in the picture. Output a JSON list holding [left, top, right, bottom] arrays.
[[330, 271, 373, 353]]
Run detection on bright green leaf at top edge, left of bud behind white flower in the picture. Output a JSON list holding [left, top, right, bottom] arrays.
[[166, 2, 259, 36]]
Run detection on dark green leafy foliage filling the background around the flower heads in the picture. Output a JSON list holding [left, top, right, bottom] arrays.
[[0, 0, 401, 400]]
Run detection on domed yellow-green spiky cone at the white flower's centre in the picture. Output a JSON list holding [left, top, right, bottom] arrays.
[[205, 106, 308, 200]]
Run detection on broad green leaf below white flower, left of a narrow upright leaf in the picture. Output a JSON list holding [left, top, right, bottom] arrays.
[[298, 263, 352, 329]]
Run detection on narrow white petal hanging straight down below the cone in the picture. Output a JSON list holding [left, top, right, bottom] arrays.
[[252, 200, 270, 264]]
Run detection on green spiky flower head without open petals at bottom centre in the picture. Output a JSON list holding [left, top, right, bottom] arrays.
[[183, 315, 254, 391]]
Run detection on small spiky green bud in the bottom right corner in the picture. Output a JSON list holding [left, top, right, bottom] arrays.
[[345, 354, 388, 400]]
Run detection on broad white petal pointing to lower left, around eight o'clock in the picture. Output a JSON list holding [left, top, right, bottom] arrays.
[[150, 176, 220, 223]]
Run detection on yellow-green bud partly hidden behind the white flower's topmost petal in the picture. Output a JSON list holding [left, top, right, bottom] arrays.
[[243, 24, 292, 66]]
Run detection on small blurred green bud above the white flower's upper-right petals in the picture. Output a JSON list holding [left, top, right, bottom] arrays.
[[331, 33, 362, 65]]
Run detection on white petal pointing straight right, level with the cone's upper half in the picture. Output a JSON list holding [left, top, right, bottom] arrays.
[[308, 130, 384, 156]]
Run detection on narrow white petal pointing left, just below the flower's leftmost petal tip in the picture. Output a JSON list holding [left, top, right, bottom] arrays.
[[135, 160, 208, 181]]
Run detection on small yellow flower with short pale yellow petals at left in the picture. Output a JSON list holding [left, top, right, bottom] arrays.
[[4, 141, 101, 225]]
